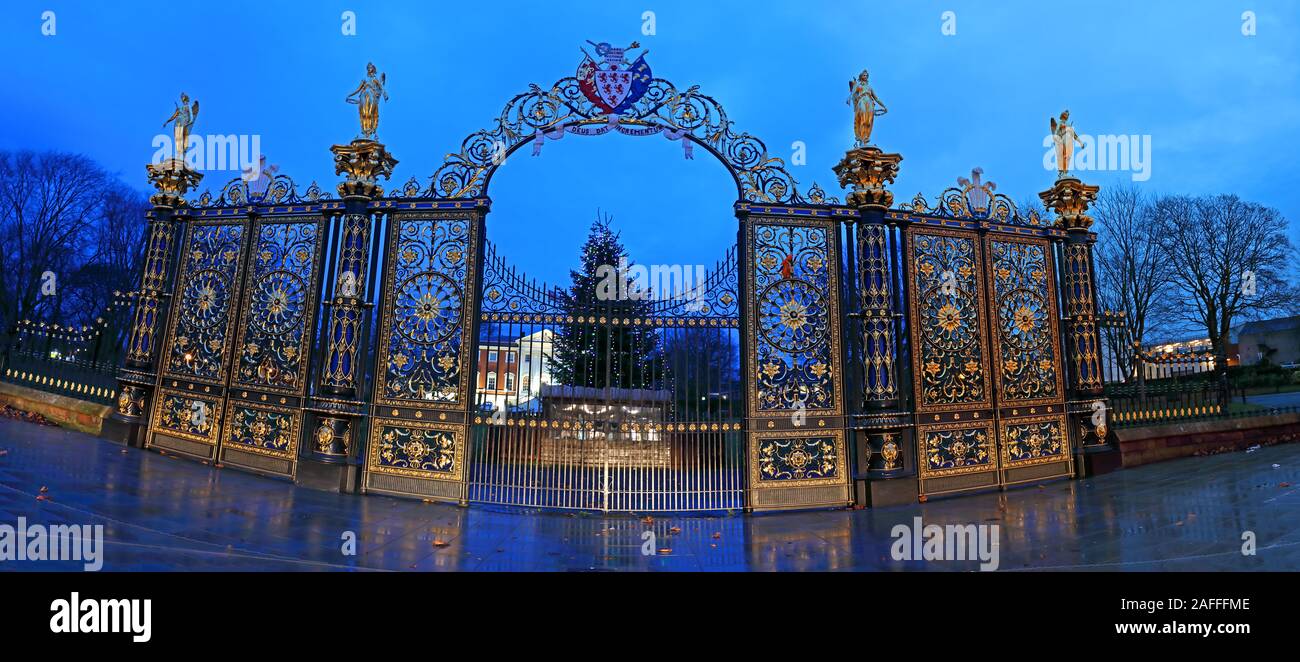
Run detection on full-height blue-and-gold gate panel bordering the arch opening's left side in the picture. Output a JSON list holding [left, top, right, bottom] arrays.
[[365, 212, 481, 501]]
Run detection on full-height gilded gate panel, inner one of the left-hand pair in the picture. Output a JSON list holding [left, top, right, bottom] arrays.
[[221, 217, 324, 476]]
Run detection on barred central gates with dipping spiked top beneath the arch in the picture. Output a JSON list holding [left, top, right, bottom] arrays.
[[468, 245, 746, 511]]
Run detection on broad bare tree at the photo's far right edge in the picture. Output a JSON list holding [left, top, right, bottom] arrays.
[[1153, 195, 1296, 371]]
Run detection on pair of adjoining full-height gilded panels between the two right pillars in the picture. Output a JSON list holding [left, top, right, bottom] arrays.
[[907, 225, 1074, 494]]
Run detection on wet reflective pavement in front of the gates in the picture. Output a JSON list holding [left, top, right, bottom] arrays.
[[0, 420, 1300, 571]]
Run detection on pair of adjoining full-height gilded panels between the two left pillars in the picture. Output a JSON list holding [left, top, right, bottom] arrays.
[[150, 216, 322, 477]]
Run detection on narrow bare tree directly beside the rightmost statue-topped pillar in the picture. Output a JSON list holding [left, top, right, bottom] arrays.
[[1093, 185, 1170, 378]]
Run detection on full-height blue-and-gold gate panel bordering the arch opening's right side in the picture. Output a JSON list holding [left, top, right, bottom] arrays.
[[744, 216, 849, 510]]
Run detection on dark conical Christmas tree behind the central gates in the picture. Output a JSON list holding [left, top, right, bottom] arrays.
[[553, 212, 663, 389]]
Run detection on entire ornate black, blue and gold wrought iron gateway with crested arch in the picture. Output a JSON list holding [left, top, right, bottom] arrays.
[[112, 44, 1108, 511]]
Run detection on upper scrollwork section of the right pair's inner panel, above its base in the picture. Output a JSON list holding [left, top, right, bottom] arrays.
[[907, 229, 991, 412]]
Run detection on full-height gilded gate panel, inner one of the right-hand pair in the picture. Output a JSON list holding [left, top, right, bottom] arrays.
[[907, 226, 998, 494]]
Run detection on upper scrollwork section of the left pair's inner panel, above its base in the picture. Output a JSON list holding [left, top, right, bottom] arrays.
[[233, 218, 322, 395]]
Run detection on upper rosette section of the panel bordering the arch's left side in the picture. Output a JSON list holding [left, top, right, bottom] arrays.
[[376, 215, 477, 411]]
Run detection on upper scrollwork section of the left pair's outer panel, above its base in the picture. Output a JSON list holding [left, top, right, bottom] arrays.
[[165, 222, 247, 385]]
